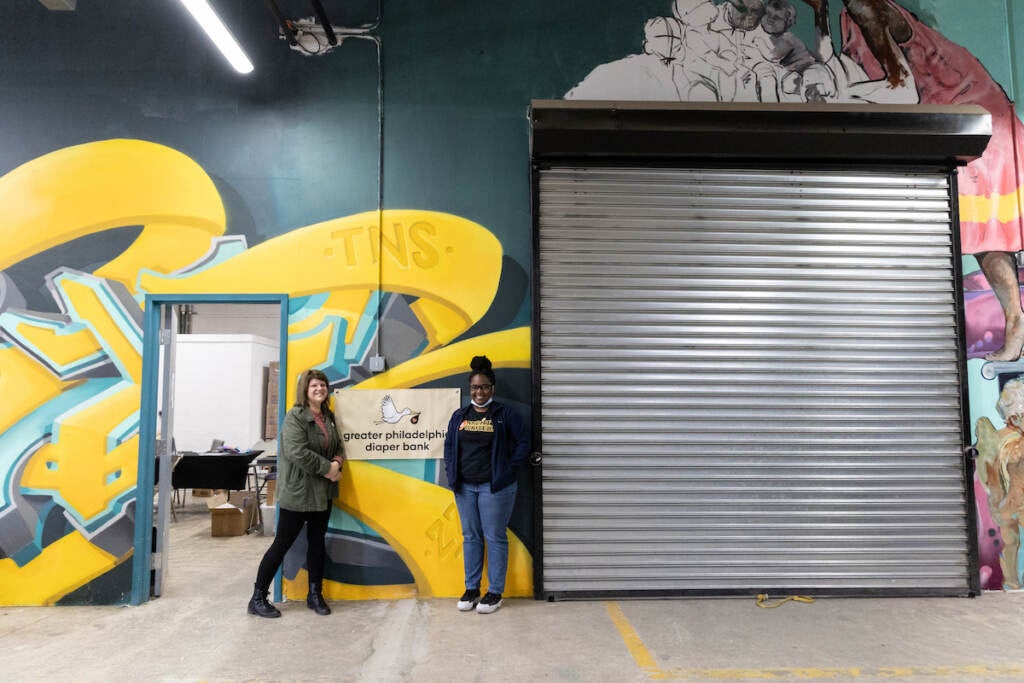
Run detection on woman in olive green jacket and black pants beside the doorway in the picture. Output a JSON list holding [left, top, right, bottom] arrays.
[[249, 370, 345, 617]]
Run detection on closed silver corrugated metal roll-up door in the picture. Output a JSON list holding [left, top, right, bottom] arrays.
[[538, 166, 971, 597]]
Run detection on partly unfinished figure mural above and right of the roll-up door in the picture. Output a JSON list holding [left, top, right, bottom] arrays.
[[565, 0, 1024, 589]]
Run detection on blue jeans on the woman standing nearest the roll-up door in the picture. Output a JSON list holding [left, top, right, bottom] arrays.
[[455, 482, 518, 594]]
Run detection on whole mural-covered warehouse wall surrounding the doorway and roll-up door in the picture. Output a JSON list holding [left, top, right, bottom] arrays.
[[0, 0, 1024, 604]]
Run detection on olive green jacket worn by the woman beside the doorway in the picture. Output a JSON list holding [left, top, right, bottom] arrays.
[[276, 405, 342, 512]]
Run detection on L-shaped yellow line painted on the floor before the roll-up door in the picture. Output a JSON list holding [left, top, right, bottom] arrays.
[[604, 601, 1024, 681]]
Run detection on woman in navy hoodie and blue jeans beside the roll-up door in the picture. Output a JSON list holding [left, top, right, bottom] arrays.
[[444, 355, 529, 614]]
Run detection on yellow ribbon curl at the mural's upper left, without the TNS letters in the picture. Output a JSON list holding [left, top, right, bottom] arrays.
[[0, 139, 225, 290]]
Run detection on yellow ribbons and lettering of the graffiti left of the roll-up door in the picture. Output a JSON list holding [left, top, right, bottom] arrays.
[[0, 140, 520, 604]]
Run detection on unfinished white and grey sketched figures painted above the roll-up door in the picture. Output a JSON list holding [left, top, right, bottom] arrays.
[[565, 0, 920, 103]]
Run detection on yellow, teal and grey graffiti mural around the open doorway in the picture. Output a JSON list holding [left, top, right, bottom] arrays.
[[0, 139, 532, 604]]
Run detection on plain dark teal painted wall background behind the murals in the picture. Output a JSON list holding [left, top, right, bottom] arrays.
[[0, 0, 1024, 602]]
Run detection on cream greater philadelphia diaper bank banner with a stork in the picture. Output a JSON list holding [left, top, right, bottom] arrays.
[[334, 389, 462, 460]]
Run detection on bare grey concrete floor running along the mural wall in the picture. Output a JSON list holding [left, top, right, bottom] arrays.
[[0, 502, 1024, 683]]
